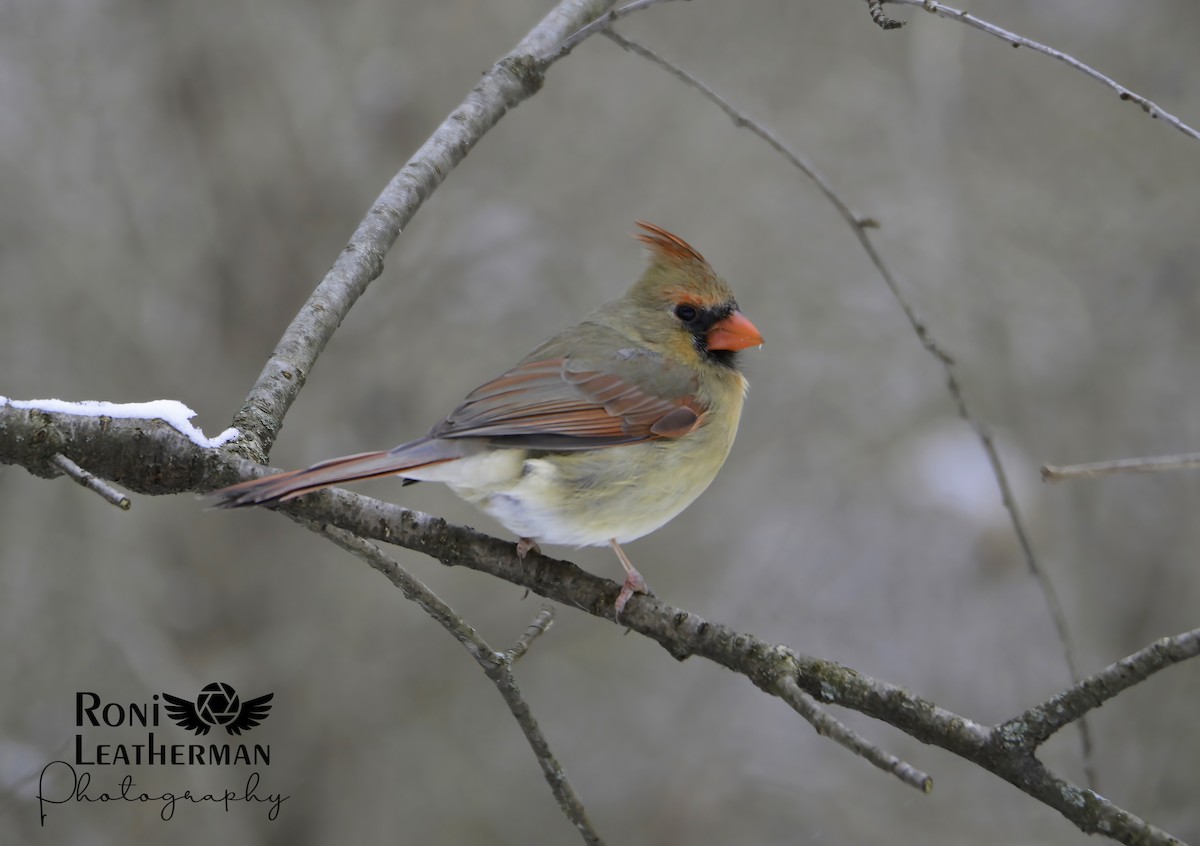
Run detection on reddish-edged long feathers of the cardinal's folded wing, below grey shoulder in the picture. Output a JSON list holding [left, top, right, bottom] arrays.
[[430, 358, 702, 449]]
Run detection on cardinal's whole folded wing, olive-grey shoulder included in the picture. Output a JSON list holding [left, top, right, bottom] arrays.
[[430, 348, 704, 450]]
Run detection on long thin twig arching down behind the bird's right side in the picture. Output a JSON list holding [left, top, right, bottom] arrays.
[[604, 29, 1097, 787]]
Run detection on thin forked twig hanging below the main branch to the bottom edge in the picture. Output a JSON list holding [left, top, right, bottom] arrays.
[[319, 518, 604, 844]]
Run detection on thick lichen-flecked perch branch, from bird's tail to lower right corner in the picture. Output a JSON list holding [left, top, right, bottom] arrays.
[[280, 490, 1180, 844]]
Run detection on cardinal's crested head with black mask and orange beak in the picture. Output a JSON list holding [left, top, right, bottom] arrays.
[[626, 221, 762, 368]]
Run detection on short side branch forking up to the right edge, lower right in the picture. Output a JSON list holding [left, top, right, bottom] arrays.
[[998, 629, 1200, 751]]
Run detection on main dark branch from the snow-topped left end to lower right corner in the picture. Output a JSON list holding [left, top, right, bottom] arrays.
[[0, 406, 1185, 844]]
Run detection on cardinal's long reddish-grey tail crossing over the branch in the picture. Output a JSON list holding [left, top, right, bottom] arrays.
[[208, 438, 463, 508]]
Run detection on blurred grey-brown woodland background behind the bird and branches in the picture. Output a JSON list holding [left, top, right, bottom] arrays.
[[0, 0, 1200, 844]]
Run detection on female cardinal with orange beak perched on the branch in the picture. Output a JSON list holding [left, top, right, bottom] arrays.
[[211, 221, 763, 622]]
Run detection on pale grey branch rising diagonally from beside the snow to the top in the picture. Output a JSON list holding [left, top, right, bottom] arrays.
[[229, 0, 613, 463]]
